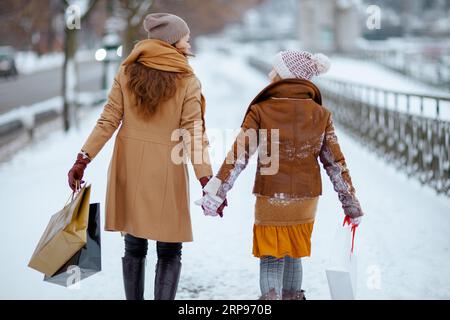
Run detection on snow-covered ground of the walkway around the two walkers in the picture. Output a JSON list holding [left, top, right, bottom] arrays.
[[0, 38, 450, 299]]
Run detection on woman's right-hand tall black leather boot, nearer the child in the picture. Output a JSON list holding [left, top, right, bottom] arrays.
[[155, 257, 181, 300]]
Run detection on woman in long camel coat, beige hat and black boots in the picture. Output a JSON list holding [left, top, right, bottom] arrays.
[[69, 14, 223, 300]]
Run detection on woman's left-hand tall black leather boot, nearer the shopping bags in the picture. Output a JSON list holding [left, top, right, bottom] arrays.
[[122, 256, 145, 300]]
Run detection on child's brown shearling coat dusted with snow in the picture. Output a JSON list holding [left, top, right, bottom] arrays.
[[216, 79, 363, 217]]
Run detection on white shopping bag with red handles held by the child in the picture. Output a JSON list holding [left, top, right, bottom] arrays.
[[325, 218, 356, 300]]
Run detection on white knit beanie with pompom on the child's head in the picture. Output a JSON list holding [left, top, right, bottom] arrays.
[[273, 50, 331, 80]]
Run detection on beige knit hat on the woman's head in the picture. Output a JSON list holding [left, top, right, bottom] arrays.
[[144, 13, 190, 44]]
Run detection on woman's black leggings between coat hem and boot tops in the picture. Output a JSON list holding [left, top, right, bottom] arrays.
[[125, 234, 182, 260]]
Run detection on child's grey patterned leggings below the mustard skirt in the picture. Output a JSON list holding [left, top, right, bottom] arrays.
[[259, 256, 303, 295]]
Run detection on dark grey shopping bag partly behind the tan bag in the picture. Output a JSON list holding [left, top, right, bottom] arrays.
[[44, 203, 102, 287]]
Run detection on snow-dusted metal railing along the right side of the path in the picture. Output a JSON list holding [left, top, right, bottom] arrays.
[[249, 57, 450, 196]]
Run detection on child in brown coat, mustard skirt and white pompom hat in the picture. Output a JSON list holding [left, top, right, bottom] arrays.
[[198, 51, 363, 300]]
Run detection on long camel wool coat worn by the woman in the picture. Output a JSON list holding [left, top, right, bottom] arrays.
[[82, 66, 212, 242]]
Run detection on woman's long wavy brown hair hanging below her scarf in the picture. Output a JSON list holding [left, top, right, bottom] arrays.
[[125, 62, 183, 119]]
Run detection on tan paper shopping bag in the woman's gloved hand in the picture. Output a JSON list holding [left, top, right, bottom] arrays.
[[28, 185, 91, 276]]
